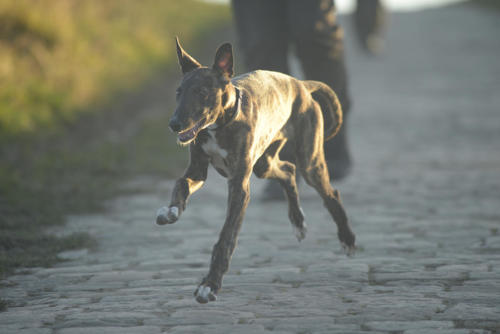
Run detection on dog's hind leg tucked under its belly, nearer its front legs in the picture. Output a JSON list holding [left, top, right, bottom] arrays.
[[253, 140, 307, 241]]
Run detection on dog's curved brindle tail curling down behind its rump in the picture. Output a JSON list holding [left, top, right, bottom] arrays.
[[304, 80, 342, 141]]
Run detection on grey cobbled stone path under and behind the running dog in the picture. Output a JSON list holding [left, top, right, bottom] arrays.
[[0, 6, 500, 334]]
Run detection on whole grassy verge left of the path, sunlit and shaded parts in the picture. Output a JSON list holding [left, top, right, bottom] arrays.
[[0, 0, 230, 282]]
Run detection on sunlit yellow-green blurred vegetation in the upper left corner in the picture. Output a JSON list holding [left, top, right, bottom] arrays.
[[0, 0, 228, 139]]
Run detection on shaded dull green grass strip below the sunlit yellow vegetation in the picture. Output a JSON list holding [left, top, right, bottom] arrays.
[[0, 109, 186, 277]]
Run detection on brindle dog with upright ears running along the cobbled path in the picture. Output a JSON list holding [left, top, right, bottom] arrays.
[[156, 38, 355, 303]]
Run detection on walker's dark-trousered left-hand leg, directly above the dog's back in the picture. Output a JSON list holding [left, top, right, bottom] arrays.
[[232, 0, 289, 73]]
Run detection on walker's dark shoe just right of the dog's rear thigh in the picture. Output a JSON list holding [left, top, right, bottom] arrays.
[[325, 117, 352, 181]]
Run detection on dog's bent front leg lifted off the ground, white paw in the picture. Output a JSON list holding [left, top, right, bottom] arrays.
[[156, 144, 209, 225]]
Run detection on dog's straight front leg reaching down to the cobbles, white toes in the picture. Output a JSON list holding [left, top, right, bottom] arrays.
[[194, 172, 250, 303]]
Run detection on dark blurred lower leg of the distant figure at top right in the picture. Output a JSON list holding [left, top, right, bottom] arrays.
[[354, 0, 386, 55]]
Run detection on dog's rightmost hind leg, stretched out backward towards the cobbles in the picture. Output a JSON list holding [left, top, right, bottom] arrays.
[[296, 103, 355, 255]]
